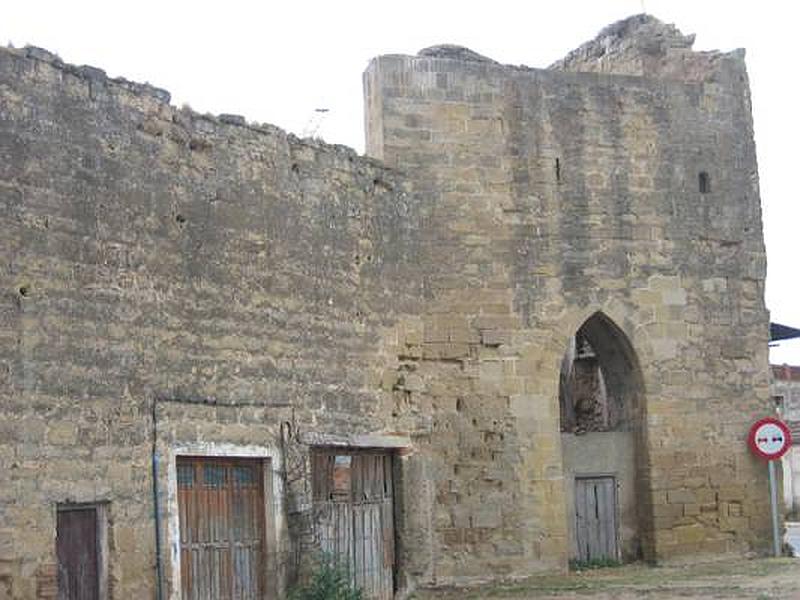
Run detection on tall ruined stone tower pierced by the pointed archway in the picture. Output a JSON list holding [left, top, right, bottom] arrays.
[[364, 15, 768, 577]]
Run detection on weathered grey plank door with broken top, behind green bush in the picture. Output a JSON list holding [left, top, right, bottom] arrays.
[[314, 450, 395, 600]]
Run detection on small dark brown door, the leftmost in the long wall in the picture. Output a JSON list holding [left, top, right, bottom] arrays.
[[56, 507, 100, 600]]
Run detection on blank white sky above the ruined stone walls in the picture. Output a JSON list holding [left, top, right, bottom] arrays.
[[6, 0, 800, 365]]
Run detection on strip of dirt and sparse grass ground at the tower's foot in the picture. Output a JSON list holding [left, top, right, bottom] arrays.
[[414, 558, 800, 600]]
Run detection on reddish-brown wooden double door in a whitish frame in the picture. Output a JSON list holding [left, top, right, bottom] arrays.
[[177, 458, 266, 600]]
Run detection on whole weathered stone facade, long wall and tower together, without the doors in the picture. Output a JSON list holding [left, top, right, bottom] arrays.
[[0, 11, 769, 599]]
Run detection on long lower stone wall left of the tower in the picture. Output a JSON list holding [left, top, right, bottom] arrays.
[[0, 49, 430, 598]]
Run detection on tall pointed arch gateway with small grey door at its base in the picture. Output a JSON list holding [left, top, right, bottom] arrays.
[[558, 312, 652, 562]]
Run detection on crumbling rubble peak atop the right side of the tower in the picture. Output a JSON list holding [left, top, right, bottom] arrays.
[[549, 14, 744, 82]]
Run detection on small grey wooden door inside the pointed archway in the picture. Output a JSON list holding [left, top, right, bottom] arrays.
[[575, 477, 619, 561]]
